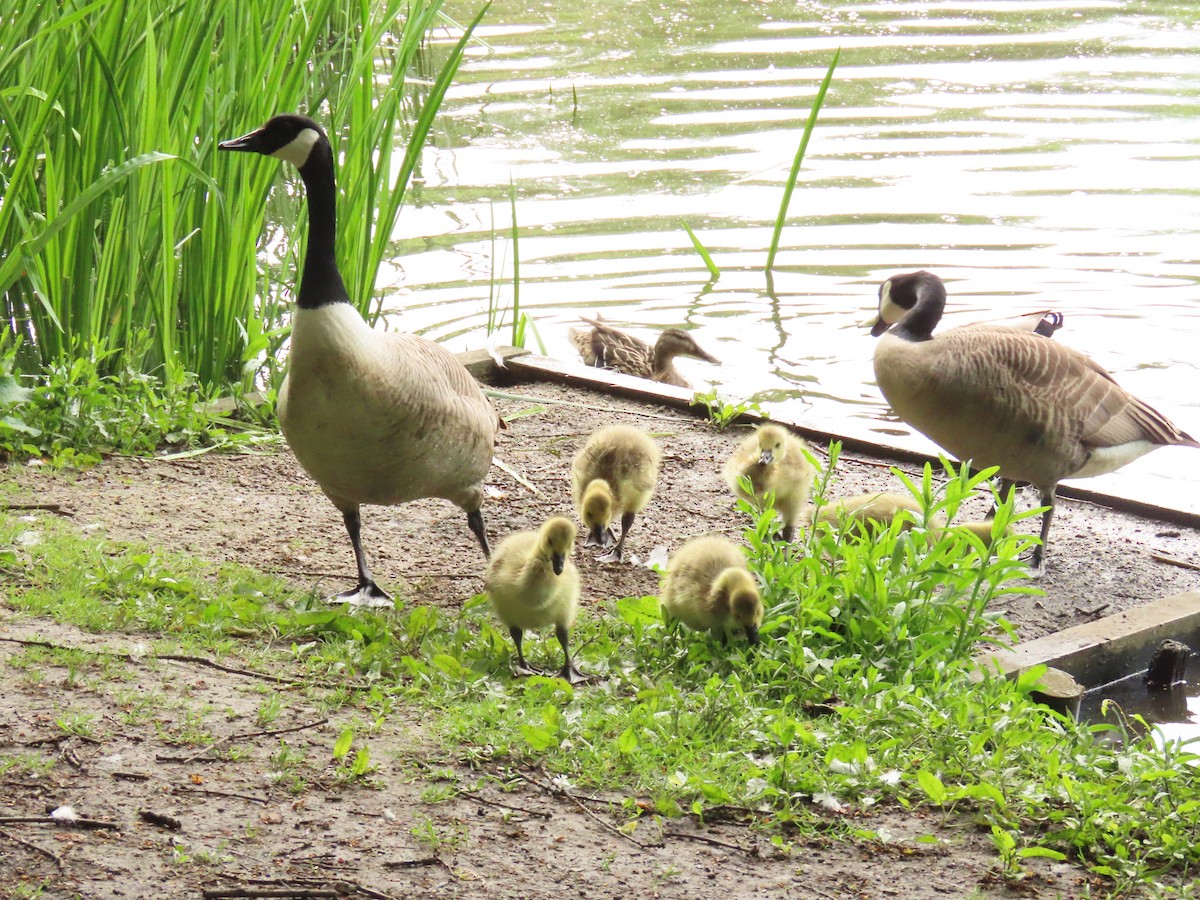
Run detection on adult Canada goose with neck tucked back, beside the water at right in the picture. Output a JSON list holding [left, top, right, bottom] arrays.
[[875, 271, 1200, 572]]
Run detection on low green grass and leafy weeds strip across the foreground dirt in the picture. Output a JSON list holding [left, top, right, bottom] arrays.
[[0, 460, 1200, 895]]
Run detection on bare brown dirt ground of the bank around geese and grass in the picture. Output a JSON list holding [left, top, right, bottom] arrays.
[[0, 369, 1200, 900]]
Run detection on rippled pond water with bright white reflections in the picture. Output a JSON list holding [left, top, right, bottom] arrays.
[[382, 0, 1200, 512]]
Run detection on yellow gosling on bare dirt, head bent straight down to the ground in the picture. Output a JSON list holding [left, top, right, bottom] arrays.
[[571, 425, 661, 563]]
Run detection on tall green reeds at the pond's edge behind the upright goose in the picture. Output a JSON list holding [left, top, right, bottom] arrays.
[[0, 0, 486, 403]]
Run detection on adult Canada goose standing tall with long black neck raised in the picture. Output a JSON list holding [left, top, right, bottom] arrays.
[[218, 115, 503, 605]]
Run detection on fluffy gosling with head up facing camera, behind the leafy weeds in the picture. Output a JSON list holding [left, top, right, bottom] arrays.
[[722, 425, 816, 541]]
